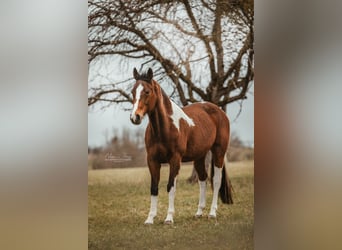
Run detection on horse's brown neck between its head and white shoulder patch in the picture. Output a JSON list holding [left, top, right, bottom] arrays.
[[149, 89, 171, 141]]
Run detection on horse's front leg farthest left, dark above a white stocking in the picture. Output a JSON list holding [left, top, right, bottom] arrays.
[[145, 159, 161, 224]]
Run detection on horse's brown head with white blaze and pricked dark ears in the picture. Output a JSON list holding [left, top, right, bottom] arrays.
[[131, 68, 157, 124]]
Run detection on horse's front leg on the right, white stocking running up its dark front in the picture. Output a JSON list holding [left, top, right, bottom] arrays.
[[165, 155, 181, 224]]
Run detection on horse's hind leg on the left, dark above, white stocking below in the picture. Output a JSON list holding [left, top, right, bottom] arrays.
[[194, 154, 211, 217]]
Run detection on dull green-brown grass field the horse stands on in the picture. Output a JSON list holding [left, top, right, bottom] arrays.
[[88, 161, 254, 250]]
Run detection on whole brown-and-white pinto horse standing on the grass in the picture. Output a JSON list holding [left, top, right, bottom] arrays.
[[130, 68, 233, 224]]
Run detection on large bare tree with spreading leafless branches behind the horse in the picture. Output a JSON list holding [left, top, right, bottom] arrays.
[[88, 0, 254, 110]]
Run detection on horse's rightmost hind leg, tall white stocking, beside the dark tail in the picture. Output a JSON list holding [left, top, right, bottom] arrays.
[[209, 145, 225, 218]]
